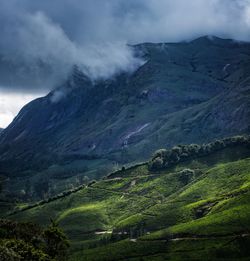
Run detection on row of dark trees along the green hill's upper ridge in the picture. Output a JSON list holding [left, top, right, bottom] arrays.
[[149, 136, 250, 170]]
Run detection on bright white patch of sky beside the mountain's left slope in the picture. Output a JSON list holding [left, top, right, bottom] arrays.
[[0, 92, 39, 128]]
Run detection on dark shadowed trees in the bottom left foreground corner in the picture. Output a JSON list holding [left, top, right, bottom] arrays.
[[0, 219, 69, 261]]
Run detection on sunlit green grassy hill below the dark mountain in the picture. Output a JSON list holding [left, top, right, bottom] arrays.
[[9, 136, 250, 260]]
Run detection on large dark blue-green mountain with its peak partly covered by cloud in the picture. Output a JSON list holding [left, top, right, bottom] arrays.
[[0, 37, 250, 197]]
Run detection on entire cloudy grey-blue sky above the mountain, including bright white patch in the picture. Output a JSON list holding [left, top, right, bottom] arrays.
[[0, 0, 250, 127]]
